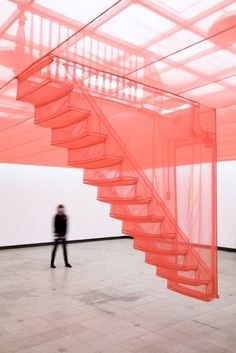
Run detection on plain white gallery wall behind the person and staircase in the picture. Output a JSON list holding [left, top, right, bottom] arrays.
[[0, 162, 236, 248]]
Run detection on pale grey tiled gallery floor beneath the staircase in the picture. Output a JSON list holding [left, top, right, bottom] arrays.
[[0, 239, 236, 353]]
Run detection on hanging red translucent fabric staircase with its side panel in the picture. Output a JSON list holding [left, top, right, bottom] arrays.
[[17, 56, 217, 301]]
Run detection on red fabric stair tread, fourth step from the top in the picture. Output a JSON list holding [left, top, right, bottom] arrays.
[[68, 156, 123, 169]]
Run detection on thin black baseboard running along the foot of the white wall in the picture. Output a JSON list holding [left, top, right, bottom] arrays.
[[0, 235, 236, 252]]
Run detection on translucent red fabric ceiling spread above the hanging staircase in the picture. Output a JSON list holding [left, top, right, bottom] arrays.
[[0, 0, 236, 165]]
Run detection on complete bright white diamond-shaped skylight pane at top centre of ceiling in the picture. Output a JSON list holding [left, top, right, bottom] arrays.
[[99, 4, 175, 45]]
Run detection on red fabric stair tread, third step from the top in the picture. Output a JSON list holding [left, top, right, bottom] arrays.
[[52, 133, 108, 149]]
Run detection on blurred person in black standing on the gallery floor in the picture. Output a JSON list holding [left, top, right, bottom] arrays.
[[51, 205, 72, 268]]
